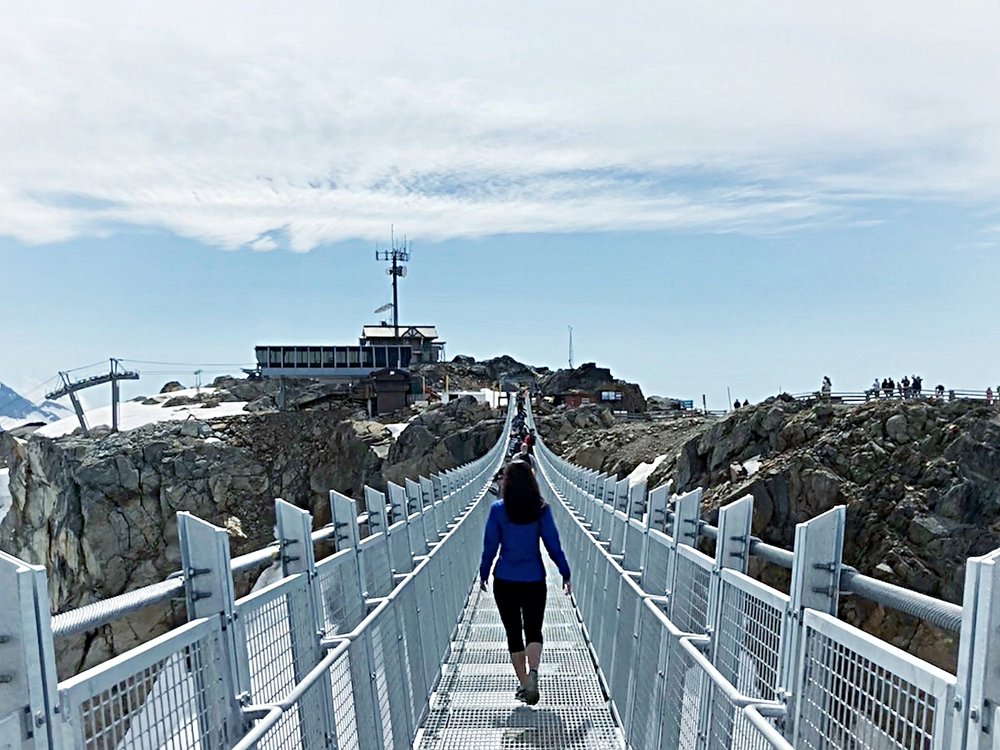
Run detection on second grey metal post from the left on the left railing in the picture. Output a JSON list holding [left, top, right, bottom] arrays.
[[177, 511, 250, 750]]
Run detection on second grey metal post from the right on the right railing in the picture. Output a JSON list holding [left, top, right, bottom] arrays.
[[780, 505, 847, 742]]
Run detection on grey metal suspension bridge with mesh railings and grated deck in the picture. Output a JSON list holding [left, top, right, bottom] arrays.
[[0, 407, 1000, 750]]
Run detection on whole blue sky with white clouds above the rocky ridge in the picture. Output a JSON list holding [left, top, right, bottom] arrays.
[[0, 0, 1000, 408]]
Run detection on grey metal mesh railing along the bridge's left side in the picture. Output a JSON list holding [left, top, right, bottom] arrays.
[[0, 408, 513, 750]]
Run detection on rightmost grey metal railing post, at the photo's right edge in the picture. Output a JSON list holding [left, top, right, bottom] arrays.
[[950, 550, 1000, 750]]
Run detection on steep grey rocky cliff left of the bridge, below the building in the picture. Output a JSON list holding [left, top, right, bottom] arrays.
[[0, 384, 502, 674]]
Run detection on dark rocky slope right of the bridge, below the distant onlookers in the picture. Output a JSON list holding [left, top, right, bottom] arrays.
[[545, 398, 1000, 669]]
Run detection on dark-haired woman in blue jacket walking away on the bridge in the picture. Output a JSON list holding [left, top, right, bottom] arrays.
[[479, 461, 572, 706]]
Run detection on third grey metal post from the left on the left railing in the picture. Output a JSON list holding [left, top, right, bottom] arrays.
[[274, 500, 338, 746]]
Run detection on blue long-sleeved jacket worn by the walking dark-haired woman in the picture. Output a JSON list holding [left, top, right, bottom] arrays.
[[479, 500, 569, 582]]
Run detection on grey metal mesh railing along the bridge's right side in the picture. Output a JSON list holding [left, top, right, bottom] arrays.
[[536, 396, 1000, 750]]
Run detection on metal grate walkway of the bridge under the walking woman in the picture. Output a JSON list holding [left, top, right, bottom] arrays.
[[414, 559, 625, 750]]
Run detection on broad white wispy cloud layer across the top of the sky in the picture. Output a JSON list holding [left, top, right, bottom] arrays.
[[0, 0, 1000, 251]]
